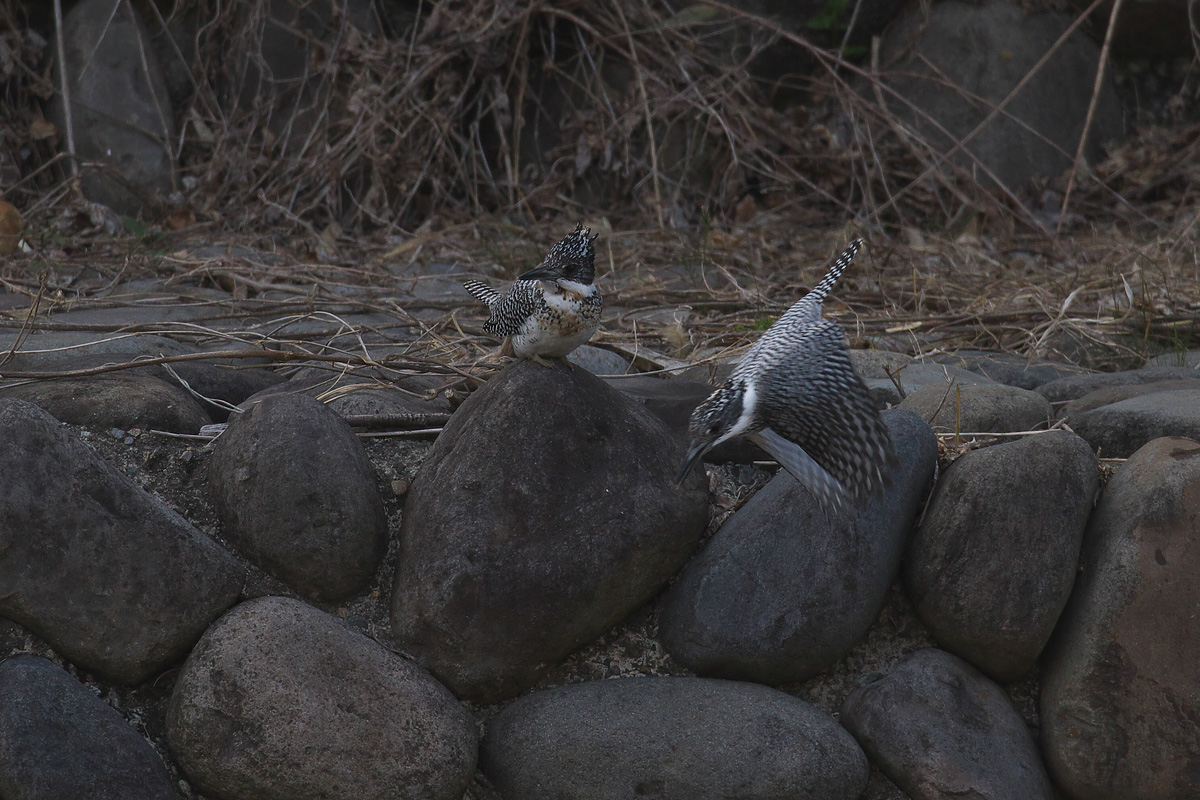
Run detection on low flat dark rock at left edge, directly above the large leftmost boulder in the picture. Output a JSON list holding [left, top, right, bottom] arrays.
[[0, 372, 212, 433]]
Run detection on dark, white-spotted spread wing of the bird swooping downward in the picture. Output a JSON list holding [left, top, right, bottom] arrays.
[[756, 318, 895, 498]]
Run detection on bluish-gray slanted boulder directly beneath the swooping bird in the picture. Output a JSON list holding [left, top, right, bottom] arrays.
[[659, 410, 937, 684]]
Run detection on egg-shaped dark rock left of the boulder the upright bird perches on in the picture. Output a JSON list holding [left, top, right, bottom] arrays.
[[206, 395, 388, 600]]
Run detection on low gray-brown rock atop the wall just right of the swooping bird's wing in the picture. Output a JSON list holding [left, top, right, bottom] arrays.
[[900, 384, 1054, 433]]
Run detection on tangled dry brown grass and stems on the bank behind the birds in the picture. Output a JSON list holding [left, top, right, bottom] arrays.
[[0, 0, 1200, 374]]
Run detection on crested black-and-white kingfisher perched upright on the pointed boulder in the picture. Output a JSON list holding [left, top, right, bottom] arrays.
[[462, 223, 604, 365]]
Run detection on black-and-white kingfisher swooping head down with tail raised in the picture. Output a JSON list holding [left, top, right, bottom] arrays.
[[677, 239, 895, 509]]
